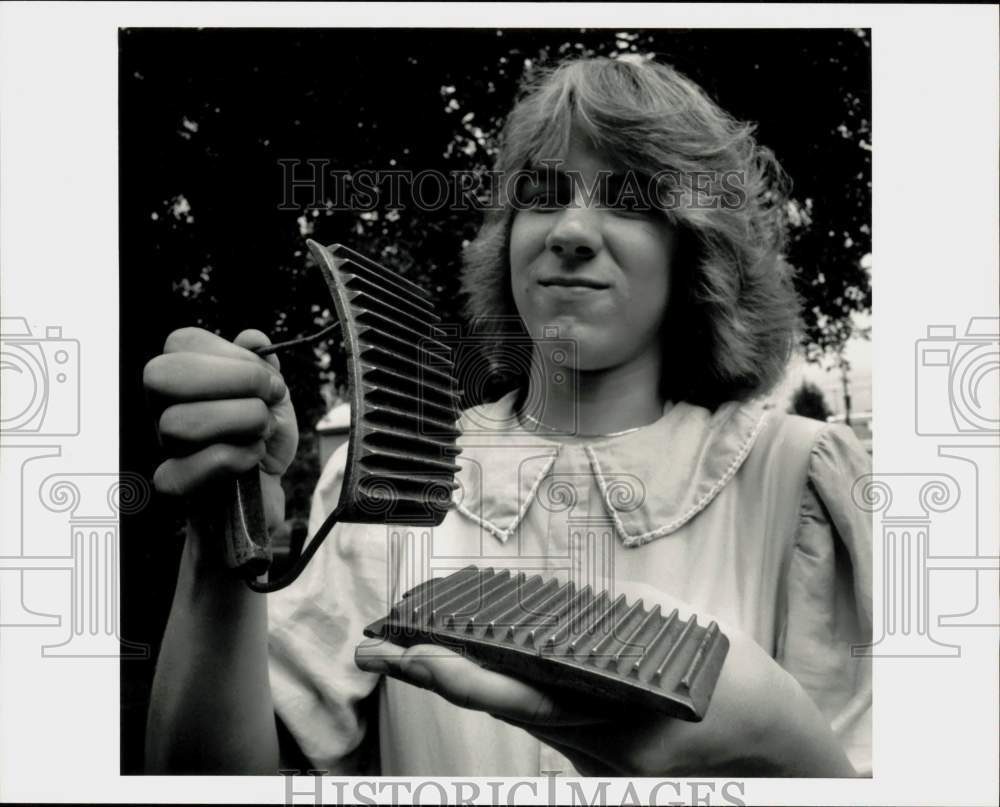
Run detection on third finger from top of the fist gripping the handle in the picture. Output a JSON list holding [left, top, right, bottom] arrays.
[[159, 398, 278, 455]]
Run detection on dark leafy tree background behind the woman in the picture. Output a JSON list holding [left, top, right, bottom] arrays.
[[115, 29, 871, 774]]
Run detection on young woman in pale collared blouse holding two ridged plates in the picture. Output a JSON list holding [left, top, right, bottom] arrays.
[[145, 59, 871, 776]]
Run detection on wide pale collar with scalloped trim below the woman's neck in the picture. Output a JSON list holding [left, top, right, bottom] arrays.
[[455, 392, 767, 546]]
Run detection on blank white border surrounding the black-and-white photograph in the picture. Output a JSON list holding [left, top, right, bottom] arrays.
[[0, 2, 1000, 804]]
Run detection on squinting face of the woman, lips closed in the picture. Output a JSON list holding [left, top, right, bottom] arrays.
[[510, 131, 677, 371]]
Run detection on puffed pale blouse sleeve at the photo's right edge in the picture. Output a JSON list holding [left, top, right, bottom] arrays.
[[777, 425, 872, 776]]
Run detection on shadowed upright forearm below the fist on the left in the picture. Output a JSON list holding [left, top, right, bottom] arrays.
[[146, 524, 279, 774]]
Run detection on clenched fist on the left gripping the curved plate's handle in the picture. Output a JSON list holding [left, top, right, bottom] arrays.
[[143, 328, 298, 548]]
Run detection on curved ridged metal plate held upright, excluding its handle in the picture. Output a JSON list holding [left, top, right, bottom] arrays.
[[309, 241, 460, 525]]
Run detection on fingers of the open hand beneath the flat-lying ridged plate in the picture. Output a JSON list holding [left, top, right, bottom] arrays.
[[355, 642, 607, 726]]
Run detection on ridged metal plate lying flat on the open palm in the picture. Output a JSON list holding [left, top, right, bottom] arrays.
[[365, 566, 729, 721]]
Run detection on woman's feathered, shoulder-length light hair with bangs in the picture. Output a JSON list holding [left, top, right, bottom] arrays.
[[462, 58, 798, 408]]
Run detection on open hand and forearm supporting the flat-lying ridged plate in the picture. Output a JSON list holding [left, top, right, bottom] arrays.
[[355, 608, 855, 777]]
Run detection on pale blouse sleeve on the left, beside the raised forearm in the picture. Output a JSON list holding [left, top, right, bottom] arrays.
[[267, 443, 387, 775]]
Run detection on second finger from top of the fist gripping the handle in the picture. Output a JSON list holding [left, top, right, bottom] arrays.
[[143, 353, 288, 405]]
